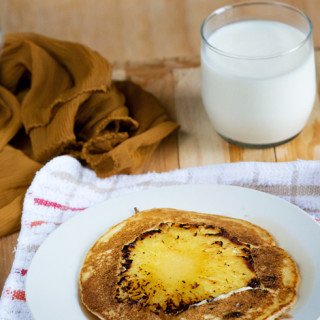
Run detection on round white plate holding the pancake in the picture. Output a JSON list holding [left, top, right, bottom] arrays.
[[26, 185, 320, 320]]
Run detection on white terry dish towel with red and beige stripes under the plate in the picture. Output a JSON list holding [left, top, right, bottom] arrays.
[[0, 156, 320, 320]]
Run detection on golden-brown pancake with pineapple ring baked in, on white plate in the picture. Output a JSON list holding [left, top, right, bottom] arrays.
[[79, 209, 299, 320]]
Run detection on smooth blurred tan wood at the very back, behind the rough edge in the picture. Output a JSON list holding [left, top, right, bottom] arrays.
[[0, 0, 320, 62]]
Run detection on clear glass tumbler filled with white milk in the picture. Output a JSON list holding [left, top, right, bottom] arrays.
[[201, 1, 316, 147]]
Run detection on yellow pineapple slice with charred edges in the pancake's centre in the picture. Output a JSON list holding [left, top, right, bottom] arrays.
[[116, 223, 255, 314]]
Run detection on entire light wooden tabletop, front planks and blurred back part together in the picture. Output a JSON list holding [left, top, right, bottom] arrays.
[[0, 0, 320, 296]]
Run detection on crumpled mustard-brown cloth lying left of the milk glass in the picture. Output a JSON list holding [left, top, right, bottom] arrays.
[[0, 33, 177, 236]]
